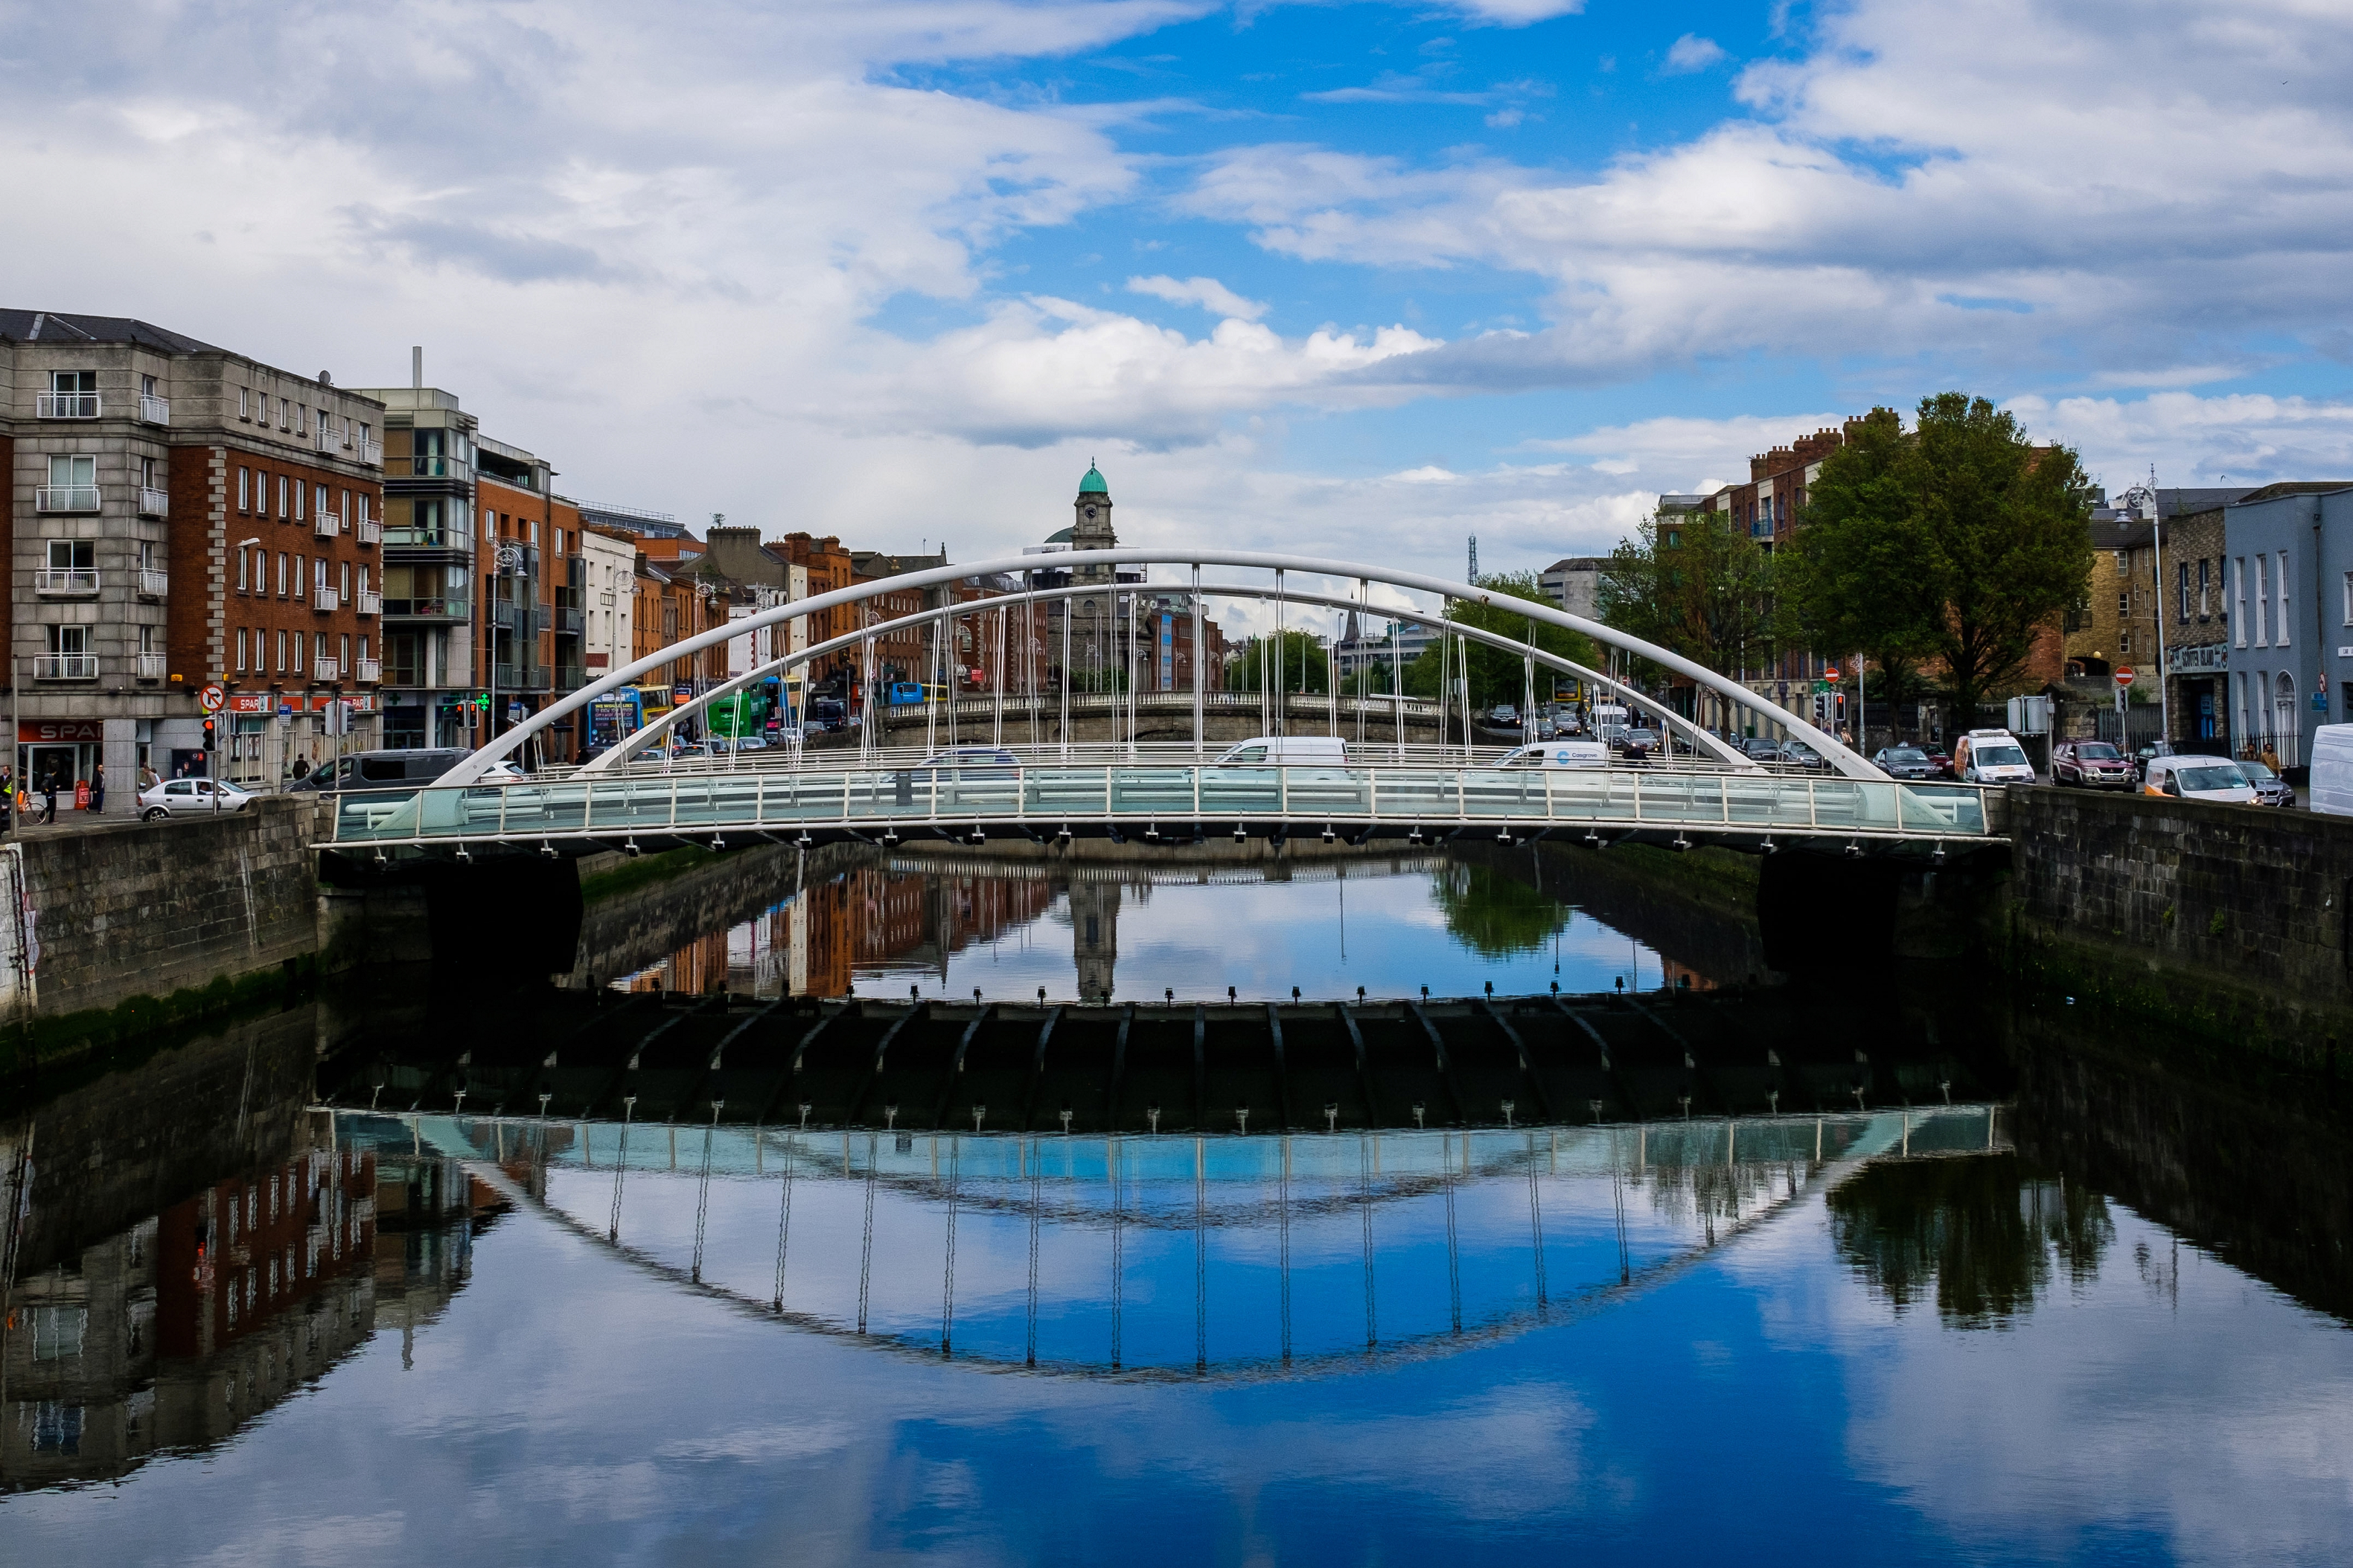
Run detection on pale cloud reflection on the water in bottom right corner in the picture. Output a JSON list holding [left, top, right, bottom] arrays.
[[1798, 1206, 2353, 1563]]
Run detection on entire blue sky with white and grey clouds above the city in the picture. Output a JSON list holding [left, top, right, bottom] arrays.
[[0, 0, 2353, 587]]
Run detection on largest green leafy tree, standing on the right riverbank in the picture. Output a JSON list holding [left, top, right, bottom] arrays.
[[1779, 393, 2092, 729]]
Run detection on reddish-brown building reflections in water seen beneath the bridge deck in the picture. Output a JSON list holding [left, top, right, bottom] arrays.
[[619, 865, 1054, 997]]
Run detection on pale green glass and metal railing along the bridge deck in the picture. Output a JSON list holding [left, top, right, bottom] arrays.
[[334, 764, 1989, 844]]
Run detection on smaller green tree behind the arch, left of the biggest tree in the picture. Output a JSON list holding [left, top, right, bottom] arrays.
[[1598, 510, 1774, 677]]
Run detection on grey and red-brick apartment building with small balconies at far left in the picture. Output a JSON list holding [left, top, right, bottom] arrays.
[[0, 311, 384, 813]]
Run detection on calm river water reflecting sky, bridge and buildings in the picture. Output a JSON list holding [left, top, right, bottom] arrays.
[[0, 860, 2353, 1563]]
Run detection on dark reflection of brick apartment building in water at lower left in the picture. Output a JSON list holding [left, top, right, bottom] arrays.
[[0, 1147, 487, 1491]]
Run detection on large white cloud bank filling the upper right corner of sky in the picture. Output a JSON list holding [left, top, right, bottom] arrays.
[[1186, 0, 2353, 388]]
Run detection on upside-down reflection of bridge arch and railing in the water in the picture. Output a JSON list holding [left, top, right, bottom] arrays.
[[381, 1105, 2000, 1378]]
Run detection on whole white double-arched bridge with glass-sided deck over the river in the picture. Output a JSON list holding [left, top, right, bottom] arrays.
[[329, 548, 1993, 858]]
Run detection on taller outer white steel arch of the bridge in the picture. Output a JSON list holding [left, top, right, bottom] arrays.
[[436, 545, 1887, 785]]
